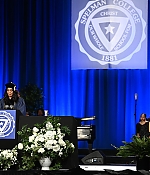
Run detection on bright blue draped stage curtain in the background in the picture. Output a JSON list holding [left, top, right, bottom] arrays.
[[0, 0, 150, 148]]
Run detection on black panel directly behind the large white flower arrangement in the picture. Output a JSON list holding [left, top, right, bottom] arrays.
[[19, 116, 78, 169]]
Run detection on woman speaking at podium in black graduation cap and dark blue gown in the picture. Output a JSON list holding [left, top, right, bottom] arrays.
[[0, 82, 26, 115]]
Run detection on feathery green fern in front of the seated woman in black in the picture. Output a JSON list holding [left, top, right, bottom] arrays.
[[117, 136, 150, 158]]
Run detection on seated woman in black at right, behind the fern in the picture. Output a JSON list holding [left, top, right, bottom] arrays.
[[136, 113, 150, 138]]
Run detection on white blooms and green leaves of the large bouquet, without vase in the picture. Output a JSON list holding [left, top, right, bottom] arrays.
[[18, 116, 74, 170]]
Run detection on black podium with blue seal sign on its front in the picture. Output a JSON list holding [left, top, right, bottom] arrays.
[[0, 110, 23, 149]]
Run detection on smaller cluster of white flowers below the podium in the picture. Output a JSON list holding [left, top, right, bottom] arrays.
[[0, 147, 18, 170]]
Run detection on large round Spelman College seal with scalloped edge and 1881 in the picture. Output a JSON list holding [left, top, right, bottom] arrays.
[[75, 0, 146, 65]]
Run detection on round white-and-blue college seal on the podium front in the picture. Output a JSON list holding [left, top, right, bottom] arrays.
[[0, 111, 15, 137]]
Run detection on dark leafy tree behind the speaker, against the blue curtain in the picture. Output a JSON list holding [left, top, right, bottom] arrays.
[[20, 83, 44, 115]]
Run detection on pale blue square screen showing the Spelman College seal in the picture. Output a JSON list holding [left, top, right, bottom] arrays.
[[71, 0, 148, 69]]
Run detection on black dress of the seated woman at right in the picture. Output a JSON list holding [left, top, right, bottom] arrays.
[[136, 122, 150, 138]]
